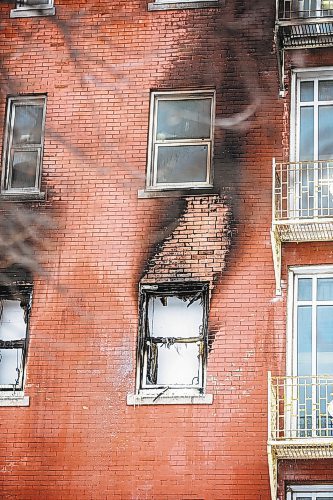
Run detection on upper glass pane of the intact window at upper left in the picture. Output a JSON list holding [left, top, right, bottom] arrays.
[[13, 104, 43, 144]]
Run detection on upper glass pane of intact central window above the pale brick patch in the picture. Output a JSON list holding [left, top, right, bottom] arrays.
[[156, 99, 211, 140]]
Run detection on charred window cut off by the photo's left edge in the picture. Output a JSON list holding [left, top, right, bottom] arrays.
[[0, 284, 32, 398]]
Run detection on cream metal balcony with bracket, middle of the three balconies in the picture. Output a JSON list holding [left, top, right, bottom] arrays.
[[271, 160, 333, 295]]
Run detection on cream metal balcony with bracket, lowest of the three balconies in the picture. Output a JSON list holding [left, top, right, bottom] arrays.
[[268, 373, 333, 500]]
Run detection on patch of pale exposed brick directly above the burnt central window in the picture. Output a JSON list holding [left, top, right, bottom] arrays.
[[141, 195, 232, 290]]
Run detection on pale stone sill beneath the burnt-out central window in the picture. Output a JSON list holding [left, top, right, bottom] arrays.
[[127, 394, 213, 406]]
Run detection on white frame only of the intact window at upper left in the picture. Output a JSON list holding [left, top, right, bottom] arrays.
[[1, 95, 46, 196]]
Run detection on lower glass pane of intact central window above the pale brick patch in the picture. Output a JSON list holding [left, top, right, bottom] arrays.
[[156, 146, 208, 184]]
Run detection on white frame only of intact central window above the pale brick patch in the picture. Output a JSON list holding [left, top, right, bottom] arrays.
[[146, 89, 216, 192]]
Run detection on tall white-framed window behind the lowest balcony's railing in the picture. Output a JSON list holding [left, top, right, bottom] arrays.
[[286, 266, 333, 438]]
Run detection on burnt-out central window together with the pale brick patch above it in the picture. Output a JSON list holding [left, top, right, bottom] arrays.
[[127, 195, 232, 404]]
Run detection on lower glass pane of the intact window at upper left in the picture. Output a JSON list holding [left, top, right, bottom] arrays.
[[11, 151, 38, 188]]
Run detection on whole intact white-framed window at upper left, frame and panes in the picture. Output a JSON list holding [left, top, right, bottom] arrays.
[[2, 96, 46, 194]]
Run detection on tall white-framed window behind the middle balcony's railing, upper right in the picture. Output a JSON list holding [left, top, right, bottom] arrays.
[[289, 68, 333, 218]]
